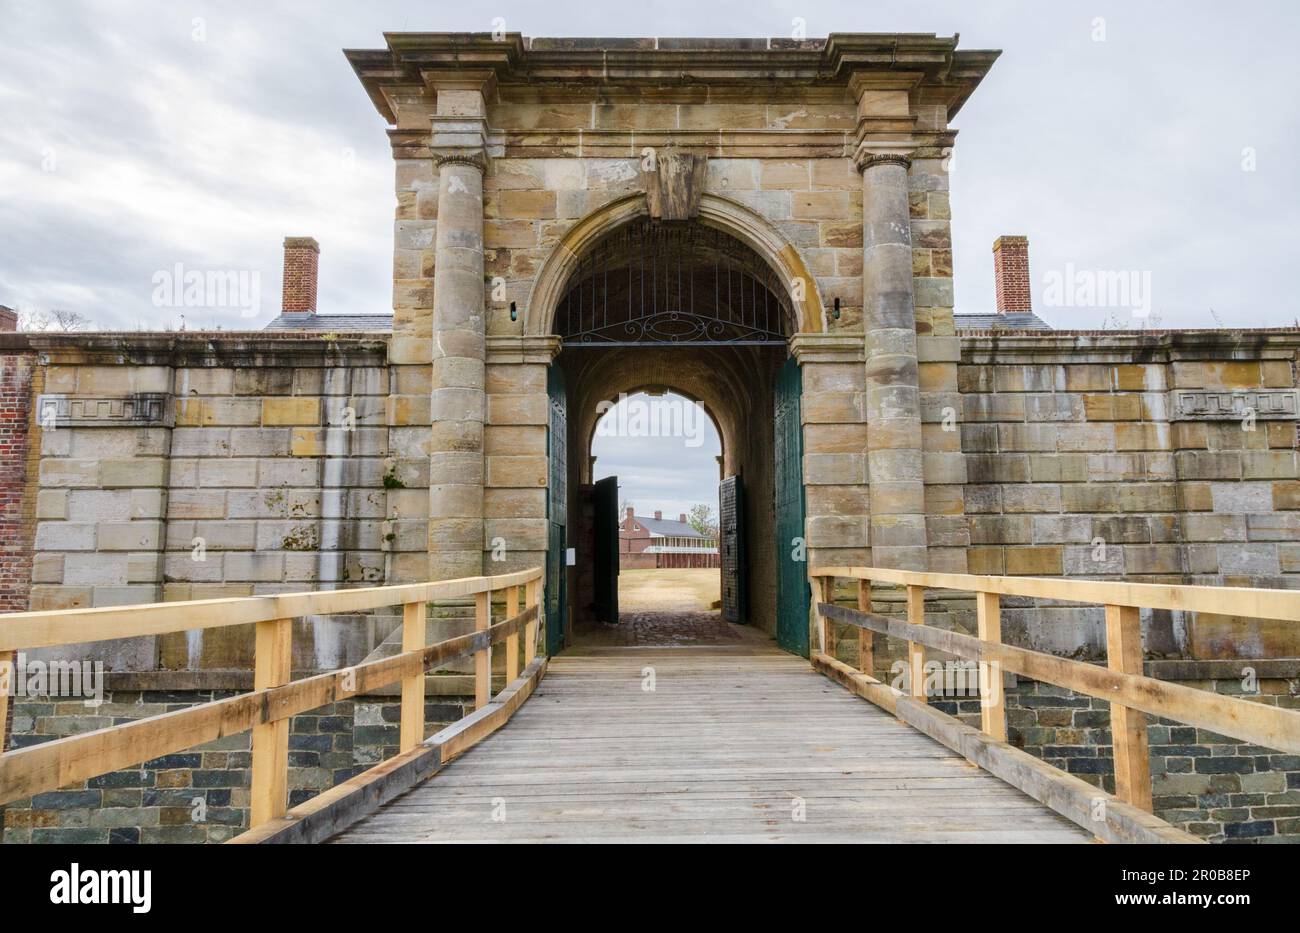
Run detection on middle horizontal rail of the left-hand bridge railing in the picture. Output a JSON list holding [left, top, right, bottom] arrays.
[[0, 608, 537, 803]]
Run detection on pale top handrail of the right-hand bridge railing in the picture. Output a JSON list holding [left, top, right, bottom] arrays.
[[811, 567, 1300, 621]]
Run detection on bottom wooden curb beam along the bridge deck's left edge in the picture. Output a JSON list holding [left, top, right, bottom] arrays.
[[228, 659, 546, 845]]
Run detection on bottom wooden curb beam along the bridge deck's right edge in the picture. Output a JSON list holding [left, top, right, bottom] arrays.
[[813, 655, 1204, 845]]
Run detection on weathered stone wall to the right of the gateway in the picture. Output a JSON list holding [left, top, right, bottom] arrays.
[[959, 331, 1300, 659]]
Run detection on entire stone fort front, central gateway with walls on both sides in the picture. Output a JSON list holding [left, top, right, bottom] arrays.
[[0, 34, 1300, 841]]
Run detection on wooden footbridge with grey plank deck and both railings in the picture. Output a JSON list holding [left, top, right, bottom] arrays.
[[0, 568, 1300, 843]]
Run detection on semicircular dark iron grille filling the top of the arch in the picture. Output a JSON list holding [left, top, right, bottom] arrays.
[[556, 218, 796, 347]]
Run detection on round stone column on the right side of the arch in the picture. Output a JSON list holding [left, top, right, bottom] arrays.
[[858, 148, 927, 570]]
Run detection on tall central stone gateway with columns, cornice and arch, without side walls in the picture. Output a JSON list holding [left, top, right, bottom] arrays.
[[348, 34, 993, 654]]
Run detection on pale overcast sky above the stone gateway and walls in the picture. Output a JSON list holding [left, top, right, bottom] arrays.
[[0, 0, 1300, 504]]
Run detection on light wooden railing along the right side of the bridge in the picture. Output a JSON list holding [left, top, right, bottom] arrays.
[[809, 567, 1300, 842]]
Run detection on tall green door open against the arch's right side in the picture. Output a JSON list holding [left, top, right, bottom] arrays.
[[775, 357, 811, 658]]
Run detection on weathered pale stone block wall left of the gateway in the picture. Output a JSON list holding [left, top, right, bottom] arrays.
[[23, 335, 395, 671]]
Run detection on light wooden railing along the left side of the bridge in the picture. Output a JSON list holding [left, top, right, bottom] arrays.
[[0, 568, 542, 842]]
